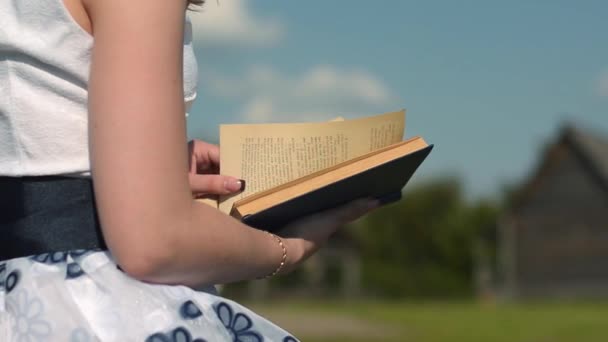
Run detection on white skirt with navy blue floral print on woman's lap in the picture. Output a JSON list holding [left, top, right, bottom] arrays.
[[0, 250, 297, 342]]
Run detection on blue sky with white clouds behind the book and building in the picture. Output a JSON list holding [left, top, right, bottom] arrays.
[[189, 0, 608, 197]]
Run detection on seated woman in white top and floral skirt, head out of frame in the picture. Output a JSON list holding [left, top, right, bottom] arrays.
[[0, 0, 377, 341]]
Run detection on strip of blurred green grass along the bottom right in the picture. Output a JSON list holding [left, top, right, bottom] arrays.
[[245, 301, 608, 342]]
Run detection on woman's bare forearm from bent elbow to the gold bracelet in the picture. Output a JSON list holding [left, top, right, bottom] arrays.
[[127, 202, 288, 286]]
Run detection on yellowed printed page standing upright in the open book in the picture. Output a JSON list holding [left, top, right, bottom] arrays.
[[219, 111, 405, 213]]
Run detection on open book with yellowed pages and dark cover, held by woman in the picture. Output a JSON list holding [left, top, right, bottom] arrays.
[[203, 110, 432, 230]]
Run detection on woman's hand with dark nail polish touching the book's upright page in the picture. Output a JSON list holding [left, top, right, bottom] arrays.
[[188, 140, 245, 197]]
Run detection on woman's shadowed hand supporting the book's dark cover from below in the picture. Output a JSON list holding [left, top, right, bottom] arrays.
[[277, 199, 380, 274]]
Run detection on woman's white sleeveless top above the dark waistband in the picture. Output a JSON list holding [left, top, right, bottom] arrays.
[[0, 0, 197, 176]]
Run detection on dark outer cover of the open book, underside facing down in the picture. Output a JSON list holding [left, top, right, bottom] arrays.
[[242, 145, 433, 231]]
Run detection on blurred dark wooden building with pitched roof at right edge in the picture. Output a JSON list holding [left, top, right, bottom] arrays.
[[498, 125, 608, 297]]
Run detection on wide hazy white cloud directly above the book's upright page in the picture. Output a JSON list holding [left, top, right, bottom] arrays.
[[202, 65, 395, 122]]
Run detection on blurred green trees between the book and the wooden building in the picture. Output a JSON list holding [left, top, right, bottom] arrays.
[[354, 178, 498, 297]]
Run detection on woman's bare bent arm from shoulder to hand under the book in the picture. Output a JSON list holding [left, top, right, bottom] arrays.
[[84, 0, 366, 285]]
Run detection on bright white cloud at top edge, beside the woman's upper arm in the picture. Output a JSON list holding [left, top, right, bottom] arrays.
[[189, 0, 285, 45]]
